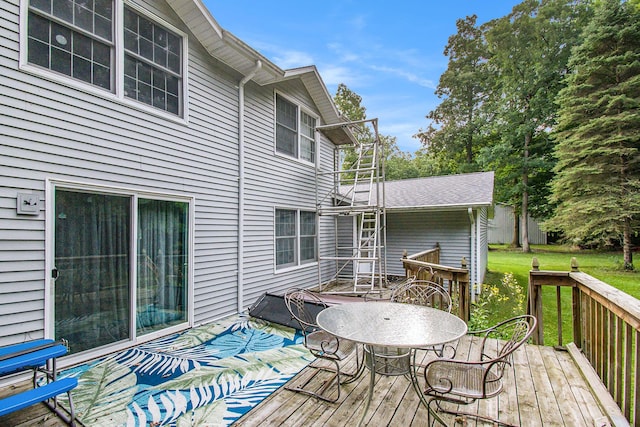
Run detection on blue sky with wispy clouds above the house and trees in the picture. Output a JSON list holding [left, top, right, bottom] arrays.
[[203, 0, 520, 152]]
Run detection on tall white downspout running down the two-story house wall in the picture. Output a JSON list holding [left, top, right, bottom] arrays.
[[238, 60, 262, 313]]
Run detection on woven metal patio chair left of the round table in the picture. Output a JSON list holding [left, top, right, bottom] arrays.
[[284, 289, 363, 402]]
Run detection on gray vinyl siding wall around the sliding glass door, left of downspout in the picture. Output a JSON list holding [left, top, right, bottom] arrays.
[[0, 0, 241, 345]]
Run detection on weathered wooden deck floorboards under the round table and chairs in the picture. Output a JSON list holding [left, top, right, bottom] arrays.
[[234, 338, 609, 427]]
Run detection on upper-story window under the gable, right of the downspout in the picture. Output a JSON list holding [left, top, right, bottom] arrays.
[[276, 95, 316, 163]]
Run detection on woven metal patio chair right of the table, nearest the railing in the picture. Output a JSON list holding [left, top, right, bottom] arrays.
[[424, 315, 536, 425]]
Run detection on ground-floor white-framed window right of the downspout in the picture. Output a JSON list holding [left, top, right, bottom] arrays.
[[275, 209, 318, 268]]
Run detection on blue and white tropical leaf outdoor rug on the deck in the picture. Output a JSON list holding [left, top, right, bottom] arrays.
[[61, 315, 313, 427]]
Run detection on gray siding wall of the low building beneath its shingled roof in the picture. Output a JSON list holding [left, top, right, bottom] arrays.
[[387, 210, 471, 275]]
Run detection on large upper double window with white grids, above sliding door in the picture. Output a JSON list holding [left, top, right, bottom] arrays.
[[27, 0, 184, 115]]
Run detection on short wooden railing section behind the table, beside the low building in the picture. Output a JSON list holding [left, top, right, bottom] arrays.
[[402, 246, 471, 322]]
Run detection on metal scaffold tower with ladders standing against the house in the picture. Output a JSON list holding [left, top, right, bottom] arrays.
[[316, 119, 386, 293]]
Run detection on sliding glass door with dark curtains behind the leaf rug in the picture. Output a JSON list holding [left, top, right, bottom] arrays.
[[53, 189, 189, 353]]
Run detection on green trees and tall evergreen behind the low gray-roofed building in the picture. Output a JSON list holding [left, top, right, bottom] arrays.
[[336, 0, 640, 268]]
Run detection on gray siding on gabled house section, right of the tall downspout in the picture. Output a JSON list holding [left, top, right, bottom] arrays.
[[243, 80, 335, 307]]
